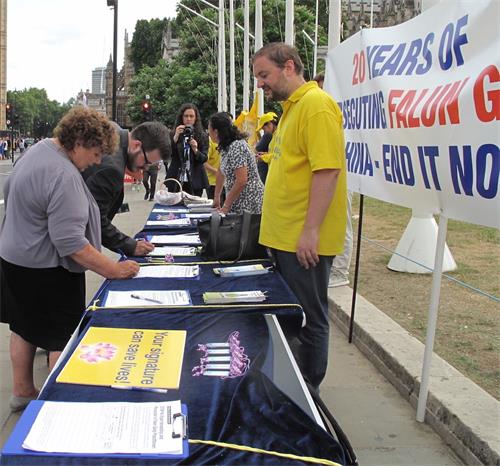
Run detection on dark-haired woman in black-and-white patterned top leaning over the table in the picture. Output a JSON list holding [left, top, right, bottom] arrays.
[[208, 112, 264, 214]]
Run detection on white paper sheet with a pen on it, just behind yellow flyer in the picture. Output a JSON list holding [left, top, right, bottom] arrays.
[[104, 290, 191, 307]]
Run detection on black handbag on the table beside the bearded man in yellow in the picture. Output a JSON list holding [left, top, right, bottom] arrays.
[[198, 212, 267, 262]]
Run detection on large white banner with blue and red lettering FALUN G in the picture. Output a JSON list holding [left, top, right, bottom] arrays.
[[325, 0, 500, 228]]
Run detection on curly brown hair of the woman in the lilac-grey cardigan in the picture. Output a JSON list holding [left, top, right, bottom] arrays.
[[54, 106, 118, 154]]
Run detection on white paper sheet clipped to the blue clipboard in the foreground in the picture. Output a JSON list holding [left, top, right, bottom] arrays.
[[23, 401, 182, 454]]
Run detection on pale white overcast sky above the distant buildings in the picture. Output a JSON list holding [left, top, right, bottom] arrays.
[[7, 0, 177, 103]]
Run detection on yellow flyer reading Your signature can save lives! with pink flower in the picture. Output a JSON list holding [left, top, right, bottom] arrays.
[[56, 327, 186, 389]]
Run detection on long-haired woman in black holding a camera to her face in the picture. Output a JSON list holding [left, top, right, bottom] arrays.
[[165, 103, 208, 196]]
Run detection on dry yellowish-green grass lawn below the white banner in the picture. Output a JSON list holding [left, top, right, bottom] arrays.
[[350, 194, 500, 399]]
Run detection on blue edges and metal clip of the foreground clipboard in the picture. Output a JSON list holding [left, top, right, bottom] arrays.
[[0, 400, 189, 464]]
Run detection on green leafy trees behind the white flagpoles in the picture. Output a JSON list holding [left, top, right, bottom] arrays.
[[128, 0, 328, 126]]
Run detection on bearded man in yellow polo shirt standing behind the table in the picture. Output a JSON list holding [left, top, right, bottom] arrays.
[[253, 43, 346, 389]]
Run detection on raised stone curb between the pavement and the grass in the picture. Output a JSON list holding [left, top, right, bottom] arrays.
[[329, 286, 500, 466]]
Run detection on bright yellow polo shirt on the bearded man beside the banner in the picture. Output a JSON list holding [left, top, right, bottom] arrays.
[[259, 81, 347, 256]]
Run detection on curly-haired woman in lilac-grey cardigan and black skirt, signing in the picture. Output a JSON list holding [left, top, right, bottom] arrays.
[[0, 107, 139, 411]]
